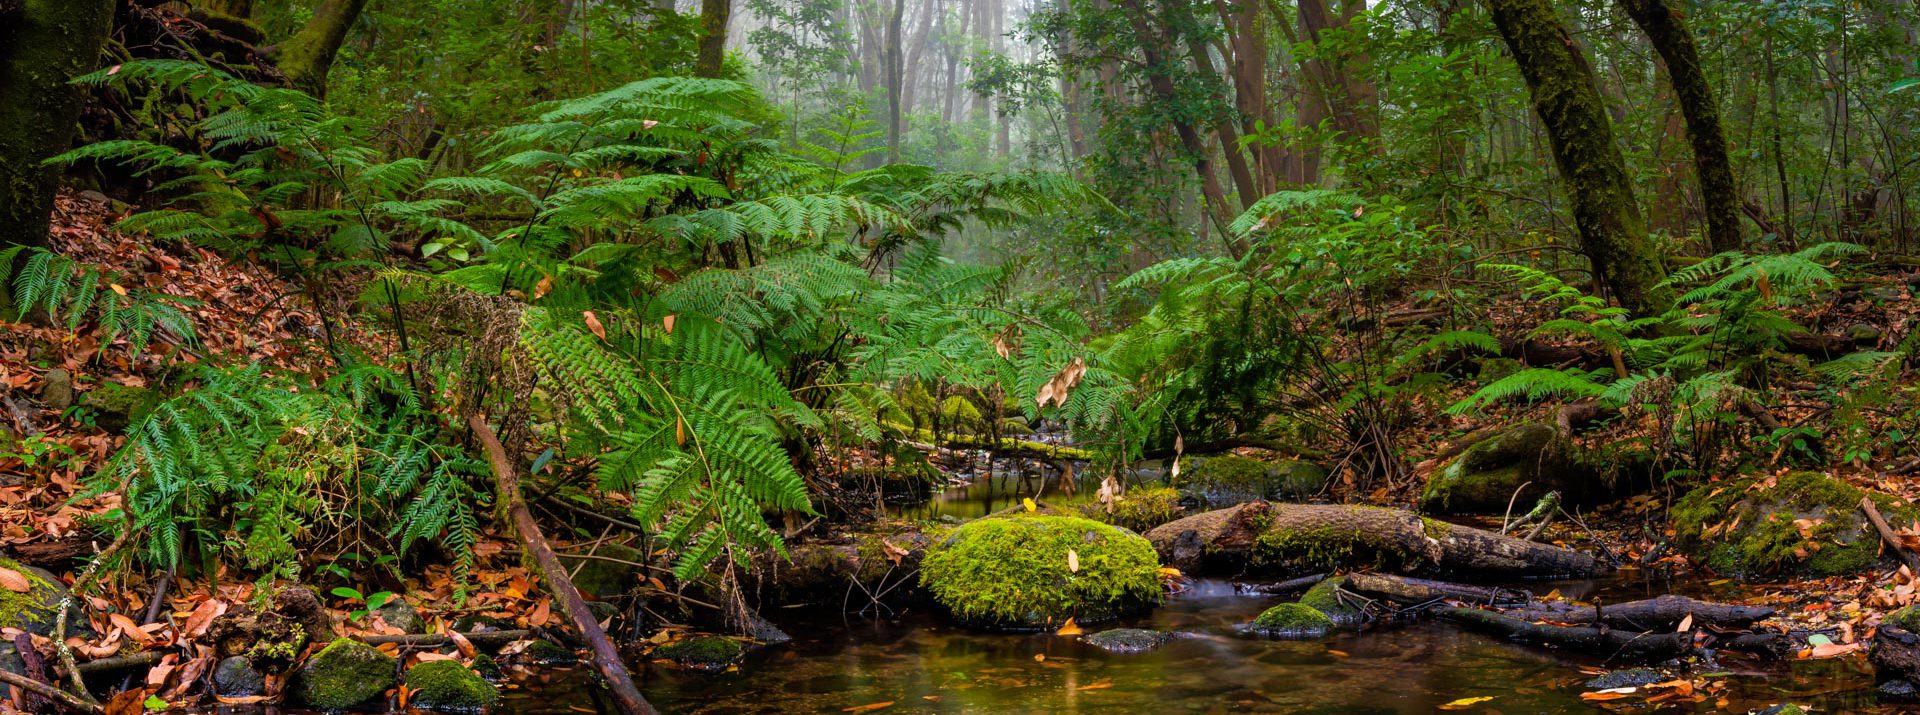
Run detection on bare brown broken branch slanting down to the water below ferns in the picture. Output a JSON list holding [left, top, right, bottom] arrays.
[[467, 413, 659, 715]]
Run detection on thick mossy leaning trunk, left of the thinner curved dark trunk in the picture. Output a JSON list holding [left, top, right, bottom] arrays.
[[1482, 0, 1670, 315]]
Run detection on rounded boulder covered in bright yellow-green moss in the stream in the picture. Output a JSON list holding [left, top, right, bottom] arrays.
[[920, 515, 1162, 630]]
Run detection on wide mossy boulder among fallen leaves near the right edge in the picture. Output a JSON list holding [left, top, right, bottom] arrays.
[[1670, 471, 1920, 577]]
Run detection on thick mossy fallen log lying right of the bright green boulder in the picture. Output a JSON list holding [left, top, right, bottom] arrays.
[[1146, 502, 1597, 579]]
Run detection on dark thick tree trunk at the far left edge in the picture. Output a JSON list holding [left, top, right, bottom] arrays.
[[0, 0, 113, 246]]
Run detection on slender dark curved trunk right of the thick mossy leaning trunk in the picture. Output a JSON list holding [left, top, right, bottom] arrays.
[[1619, 0, 1741, 254]]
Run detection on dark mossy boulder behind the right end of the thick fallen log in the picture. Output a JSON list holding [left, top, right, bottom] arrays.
[[1421, 423, 1597, 513]]
